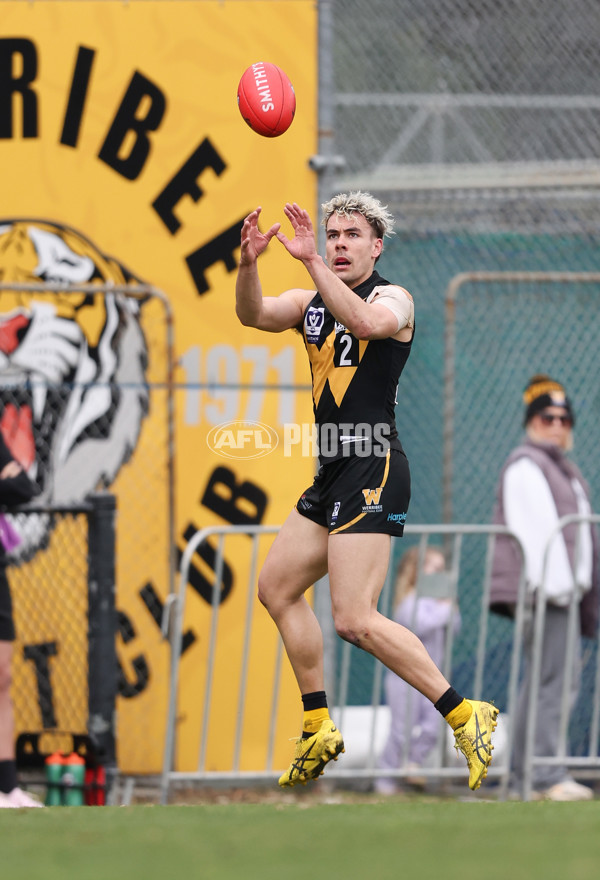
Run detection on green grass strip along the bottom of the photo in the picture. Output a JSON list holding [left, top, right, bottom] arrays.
[[0, 801, 600, 880]]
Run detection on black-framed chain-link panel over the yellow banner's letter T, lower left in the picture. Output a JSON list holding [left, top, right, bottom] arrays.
[[7, 493, 117, 778]]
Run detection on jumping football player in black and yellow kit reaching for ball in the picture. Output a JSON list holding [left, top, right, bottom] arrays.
[[236, 192, 498, 789]]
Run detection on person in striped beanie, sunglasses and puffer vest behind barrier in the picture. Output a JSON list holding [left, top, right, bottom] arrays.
[[490, 374, 599, 801]]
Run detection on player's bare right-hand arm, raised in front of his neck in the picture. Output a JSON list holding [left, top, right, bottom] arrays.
[[275, 203, 410, 339]]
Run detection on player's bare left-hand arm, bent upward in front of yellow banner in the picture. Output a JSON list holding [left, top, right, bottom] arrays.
[[235, 208, 314, 333]]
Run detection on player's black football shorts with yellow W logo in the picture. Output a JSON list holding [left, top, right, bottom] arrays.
[[296, 449, 410, 537]]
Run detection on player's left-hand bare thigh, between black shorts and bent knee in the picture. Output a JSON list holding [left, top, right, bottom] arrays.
[[259, 509, 327, 601]]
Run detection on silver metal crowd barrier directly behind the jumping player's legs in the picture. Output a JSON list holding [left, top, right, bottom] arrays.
[[161, 525, 536, 803]]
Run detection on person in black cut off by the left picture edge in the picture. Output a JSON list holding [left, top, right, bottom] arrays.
[[0, 433, 42, 808]]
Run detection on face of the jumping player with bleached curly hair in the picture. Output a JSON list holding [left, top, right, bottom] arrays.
[[325, 212, 383, 287]]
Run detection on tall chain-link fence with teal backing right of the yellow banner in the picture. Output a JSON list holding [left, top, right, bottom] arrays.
[[322, 0, 600, 736]]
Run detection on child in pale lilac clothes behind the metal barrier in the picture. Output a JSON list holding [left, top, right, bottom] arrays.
[[375, 546, 460, 795]]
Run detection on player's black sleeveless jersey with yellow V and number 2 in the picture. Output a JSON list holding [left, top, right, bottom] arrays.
[[302, 272, 414, 463]]
